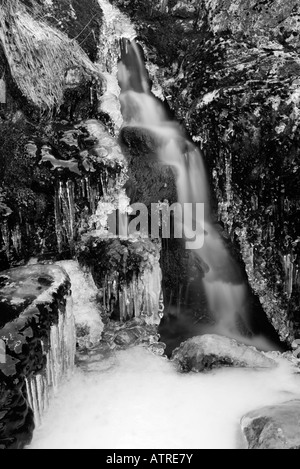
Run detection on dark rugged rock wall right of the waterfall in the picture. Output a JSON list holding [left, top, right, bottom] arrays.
[[110, 0, 300, 342]]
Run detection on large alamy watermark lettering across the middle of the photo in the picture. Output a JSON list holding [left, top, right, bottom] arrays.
[[101, 203, 205, 250]]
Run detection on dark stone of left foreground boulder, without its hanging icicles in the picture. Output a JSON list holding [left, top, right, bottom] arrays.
[[0, 265, 70, 449]]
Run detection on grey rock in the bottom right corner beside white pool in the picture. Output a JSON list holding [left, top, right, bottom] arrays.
[[241, 400, 300, 449]]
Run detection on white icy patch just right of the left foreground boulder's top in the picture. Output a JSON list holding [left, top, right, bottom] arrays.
[[56, 261, 104, 344]]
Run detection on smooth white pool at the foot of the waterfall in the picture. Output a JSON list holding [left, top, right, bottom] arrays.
[[30, 347, 299, 449]]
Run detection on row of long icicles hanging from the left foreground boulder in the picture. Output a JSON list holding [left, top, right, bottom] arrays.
[[26, 297, 76, 427]]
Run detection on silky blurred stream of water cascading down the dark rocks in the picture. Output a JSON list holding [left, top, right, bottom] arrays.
[[118, 39, 274, 349]]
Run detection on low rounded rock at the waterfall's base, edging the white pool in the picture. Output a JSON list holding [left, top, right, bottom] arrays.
[[172, 335, 276, 373]]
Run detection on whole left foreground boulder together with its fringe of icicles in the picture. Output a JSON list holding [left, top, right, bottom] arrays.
[[0, 265, 76, 449]]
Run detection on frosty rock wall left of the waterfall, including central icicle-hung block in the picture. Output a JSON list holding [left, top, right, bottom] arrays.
[[0, 0, 162, 338]]
